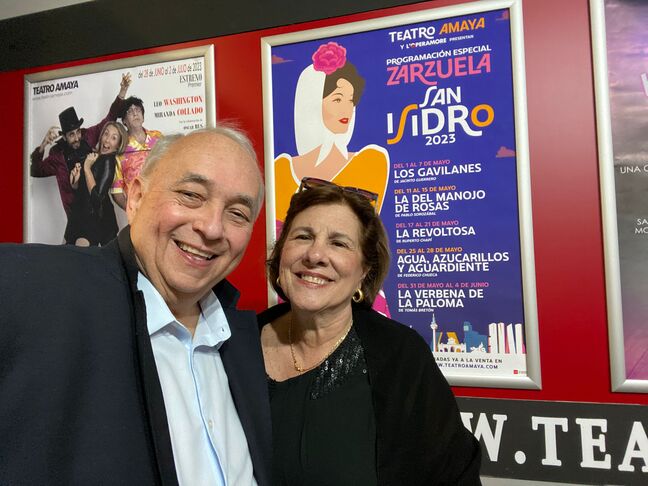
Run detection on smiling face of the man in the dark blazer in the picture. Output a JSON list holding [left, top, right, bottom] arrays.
[[127, 133, 261, 310]]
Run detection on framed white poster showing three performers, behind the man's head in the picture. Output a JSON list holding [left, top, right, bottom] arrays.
[[24, 45, 216, 245]]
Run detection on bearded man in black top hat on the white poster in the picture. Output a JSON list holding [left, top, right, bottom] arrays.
[[30, 73, 131, 244]]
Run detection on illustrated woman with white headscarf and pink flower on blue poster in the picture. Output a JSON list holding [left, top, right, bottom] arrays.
[[275, 42, 389, 222]]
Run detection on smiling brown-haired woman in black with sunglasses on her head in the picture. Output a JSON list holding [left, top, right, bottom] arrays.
[[259, 178, 480, 486]]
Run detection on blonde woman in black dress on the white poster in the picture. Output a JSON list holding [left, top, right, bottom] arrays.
[[65, 122, 128, 246]]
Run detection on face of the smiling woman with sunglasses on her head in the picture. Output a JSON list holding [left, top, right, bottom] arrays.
[[279, 204, 366, 315]]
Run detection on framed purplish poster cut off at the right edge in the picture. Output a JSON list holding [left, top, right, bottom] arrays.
[[590, 0, 648, 393]]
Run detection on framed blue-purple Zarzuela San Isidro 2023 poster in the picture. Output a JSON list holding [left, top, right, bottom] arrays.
[[262, 1, 540, 388]]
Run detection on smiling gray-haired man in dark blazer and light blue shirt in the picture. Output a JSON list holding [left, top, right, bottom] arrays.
[[0, 128, 271, 486]]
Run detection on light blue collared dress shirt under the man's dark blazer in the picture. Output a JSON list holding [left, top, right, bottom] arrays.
[[137, 273, 256, 486]]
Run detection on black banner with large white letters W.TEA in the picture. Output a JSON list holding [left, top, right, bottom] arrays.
[[457, 398, 648, 485]]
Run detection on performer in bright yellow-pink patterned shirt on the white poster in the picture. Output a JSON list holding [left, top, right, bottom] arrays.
[[110, 96, 163, 210]]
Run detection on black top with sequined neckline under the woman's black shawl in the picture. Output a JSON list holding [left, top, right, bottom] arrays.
[[268, 327, 377, 486]]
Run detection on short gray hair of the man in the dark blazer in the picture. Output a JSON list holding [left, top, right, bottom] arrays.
[[140, 123, 265, 217]]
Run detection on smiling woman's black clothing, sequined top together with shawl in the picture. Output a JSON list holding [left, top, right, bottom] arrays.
[[257, 302, 481, 486]]
